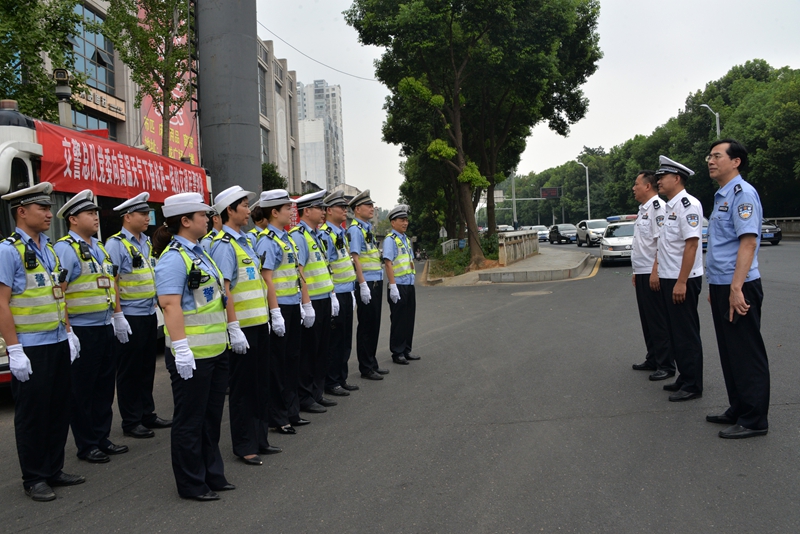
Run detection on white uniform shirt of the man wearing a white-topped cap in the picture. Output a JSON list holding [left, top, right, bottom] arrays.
[[658, 190, 703, 280]]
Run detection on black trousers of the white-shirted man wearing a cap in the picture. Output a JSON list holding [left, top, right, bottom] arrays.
[[660, 276, 703, 393]]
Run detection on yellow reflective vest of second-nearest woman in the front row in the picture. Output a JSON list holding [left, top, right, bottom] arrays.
[[214, 232, 268, 328]]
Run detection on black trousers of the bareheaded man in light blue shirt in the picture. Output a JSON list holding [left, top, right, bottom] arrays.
[[708, 279, 769, 430]]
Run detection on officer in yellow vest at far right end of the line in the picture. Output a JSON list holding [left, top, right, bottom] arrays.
[[383, 204, 419, 365]]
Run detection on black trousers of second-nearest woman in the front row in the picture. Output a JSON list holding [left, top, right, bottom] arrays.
[[228, 323, 269, 457]]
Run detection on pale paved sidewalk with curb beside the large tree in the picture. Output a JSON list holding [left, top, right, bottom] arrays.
[[425, 247, 598, 286]]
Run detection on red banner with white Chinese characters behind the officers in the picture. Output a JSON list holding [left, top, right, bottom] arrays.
[[34, 121, 209, 202]]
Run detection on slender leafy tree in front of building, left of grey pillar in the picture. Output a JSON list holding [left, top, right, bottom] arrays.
[[98, 0, 193, 156]]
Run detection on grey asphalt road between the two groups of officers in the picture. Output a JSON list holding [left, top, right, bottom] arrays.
[[0, 242, 800, 533]]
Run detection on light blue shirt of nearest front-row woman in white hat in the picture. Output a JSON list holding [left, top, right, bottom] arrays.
[[156, 235, 224, 311]]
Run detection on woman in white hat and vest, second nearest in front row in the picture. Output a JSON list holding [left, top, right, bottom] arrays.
[[211, 185, 281, 465]]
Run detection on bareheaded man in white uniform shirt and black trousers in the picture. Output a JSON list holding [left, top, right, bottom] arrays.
[[631, 170, 675, 381]]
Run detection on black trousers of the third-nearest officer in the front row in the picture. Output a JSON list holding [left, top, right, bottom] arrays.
[[268, 304, 303, 427]]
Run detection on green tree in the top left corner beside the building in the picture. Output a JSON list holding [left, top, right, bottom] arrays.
[[0, 0, 86, 122]]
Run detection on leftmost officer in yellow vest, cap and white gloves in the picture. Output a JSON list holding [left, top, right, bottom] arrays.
[[0, 183, 86, 501]]
